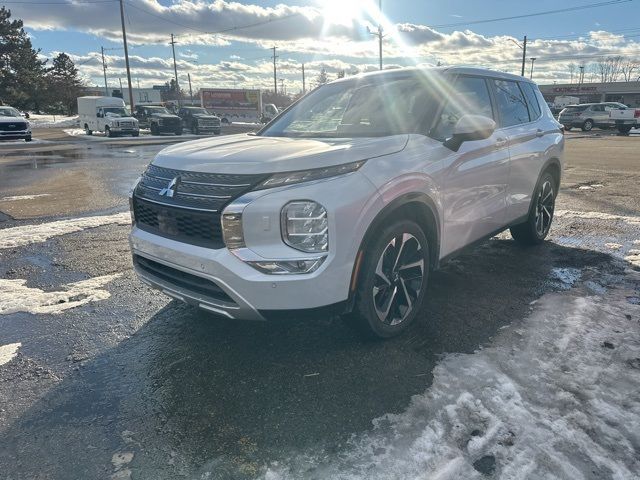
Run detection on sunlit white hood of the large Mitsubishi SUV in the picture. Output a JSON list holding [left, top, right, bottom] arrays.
[[152, 134, 408, 174]]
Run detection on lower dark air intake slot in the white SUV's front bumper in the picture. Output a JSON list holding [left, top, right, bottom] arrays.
[[133, 255, 235, 304]]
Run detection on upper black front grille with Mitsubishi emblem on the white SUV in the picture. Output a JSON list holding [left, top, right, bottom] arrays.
[[133, 165, 265, 248]]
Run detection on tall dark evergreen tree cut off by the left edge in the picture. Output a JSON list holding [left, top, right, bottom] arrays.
[[0, 6, 46, 110]]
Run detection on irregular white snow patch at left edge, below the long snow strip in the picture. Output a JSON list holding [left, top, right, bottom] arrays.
[[0, 273, 120, 315]]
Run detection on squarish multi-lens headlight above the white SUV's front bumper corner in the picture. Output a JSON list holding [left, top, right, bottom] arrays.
[[281, 201, 329, 253]]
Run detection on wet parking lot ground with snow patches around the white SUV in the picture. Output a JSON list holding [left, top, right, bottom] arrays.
[[0, 136, 640, 479]]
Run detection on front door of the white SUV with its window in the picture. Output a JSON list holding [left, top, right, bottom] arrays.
[[436, 76, 509, 257]]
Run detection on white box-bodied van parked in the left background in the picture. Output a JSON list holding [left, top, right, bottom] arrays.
[[78, 97, 140, 137]]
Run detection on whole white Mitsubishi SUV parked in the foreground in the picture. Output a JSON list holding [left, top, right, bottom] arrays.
[[131, 68, 564, 337]]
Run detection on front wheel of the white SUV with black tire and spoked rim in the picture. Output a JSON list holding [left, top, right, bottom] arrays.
[[347, 220, 429, 339]]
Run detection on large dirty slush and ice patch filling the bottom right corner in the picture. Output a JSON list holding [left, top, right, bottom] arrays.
[[262, 271, 640, 480]]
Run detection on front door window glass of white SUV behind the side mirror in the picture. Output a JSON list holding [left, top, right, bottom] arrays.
[[431, 77, 494, 140]]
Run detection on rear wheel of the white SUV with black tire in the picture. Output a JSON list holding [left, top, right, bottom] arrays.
[[509, 172, 557, 245]]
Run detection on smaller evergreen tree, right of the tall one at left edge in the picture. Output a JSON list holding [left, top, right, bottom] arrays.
[[46, 53, 82, 115]]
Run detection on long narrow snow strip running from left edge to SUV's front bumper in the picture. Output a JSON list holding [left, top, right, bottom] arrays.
[[0, 212, 131, 249]]
